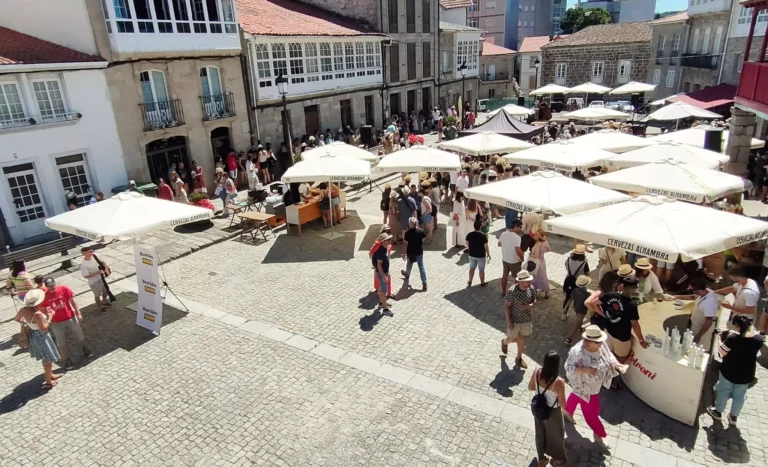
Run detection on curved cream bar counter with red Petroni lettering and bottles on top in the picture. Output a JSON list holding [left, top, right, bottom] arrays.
[[622, 301, 728, 426]]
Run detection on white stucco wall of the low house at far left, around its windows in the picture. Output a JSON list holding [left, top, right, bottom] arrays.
[[0, 69, 127, 244]]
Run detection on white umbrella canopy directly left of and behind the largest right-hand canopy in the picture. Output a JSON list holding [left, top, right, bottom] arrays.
[[464, 171, 630, 214]]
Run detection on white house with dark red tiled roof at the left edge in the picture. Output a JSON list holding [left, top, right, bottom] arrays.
[[0, 26, 128, 247]]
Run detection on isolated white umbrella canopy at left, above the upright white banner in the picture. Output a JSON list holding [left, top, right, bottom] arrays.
[[45, 191, 213, 241]]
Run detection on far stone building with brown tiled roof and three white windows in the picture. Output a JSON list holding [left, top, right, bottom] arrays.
[[540, 22, 651, 92]]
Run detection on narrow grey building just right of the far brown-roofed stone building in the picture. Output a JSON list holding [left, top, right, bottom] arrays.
[[645, 11, 689, 100]]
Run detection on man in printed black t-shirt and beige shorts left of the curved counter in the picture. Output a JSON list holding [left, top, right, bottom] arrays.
[[600, 276, 648, 364]]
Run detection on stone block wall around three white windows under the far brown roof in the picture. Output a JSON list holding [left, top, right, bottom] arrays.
[[541, 42, 651, 87]]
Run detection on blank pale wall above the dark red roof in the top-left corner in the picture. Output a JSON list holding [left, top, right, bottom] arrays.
[[0, 0, 98, 55]]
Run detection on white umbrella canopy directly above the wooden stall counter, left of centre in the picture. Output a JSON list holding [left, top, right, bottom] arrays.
[[282, 154, 371, 183]]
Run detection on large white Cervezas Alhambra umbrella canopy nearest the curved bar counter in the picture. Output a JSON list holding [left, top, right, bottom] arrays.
[[545, 196, 768, 262]]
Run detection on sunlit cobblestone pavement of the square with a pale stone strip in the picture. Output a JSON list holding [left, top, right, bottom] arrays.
[[0, 161, 768, 467]]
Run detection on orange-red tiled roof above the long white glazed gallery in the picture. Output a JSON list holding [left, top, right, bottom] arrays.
[[236, 0, 384, 36]]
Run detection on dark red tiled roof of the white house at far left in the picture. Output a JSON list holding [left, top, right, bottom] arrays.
[[0, 26, 106, 66]]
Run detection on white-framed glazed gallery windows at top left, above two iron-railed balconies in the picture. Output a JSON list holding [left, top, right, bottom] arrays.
[[102, 0, 237, 34]]
